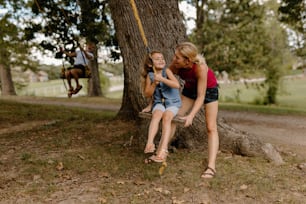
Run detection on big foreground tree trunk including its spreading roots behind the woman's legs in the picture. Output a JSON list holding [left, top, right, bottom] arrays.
[[110, 0, 284, 162]]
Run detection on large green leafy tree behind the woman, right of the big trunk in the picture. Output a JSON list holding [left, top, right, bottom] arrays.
[[191, 0, 290, 104]]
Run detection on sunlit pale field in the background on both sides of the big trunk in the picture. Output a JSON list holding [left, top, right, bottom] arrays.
[[17, 74, 306, 111]]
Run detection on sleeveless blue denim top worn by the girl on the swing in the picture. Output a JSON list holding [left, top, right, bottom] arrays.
[[148, 68, 182, 108]]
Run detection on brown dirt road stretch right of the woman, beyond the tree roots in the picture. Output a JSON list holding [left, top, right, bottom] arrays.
[[219, 110, 306, 157]]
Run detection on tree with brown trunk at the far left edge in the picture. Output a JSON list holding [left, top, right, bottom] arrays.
[[0, 0, 33, 95]]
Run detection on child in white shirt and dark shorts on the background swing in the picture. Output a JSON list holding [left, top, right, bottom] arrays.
[[61, 42, 95, 98]]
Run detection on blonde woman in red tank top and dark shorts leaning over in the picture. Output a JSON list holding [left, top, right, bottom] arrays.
[[170, 42, 219, 178]]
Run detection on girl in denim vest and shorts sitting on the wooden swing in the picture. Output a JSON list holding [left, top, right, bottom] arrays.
[[142, 51, 181, 162]]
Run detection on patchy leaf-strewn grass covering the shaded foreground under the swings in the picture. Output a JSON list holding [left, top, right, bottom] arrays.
[[0, 97, 306, 204]]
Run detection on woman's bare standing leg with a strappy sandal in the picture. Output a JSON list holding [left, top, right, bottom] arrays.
[[201, 101, 219, 178]]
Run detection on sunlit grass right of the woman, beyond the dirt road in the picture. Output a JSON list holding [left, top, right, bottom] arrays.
[[220, 77, 306, 115]]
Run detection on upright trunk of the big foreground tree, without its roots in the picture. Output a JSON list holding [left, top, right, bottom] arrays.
[[110, 0, 187, 119]]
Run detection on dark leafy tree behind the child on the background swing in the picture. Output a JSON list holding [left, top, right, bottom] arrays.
[[27, 0, 113, 96]]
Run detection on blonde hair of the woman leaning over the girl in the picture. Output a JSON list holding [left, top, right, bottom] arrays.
[[175, 42, 206, 64]]
